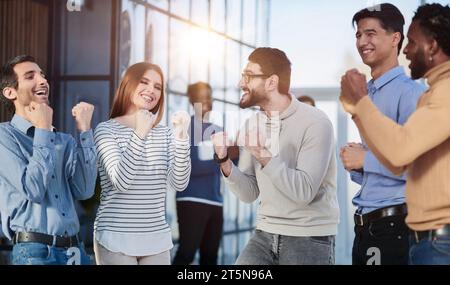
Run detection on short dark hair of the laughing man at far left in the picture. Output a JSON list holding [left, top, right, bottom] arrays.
[[0, 55, 36, 113]]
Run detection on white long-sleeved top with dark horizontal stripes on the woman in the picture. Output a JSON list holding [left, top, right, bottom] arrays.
[[94, 119, 191, 252]]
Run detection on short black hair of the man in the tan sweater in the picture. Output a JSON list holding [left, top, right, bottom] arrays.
[[413, 4, 450, 56]]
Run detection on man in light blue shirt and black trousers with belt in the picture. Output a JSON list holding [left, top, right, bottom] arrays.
[[340, 4, 425, 265]]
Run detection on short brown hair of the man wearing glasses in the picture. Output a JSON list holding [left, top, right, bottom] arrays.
[[248, 47, 291, 94]]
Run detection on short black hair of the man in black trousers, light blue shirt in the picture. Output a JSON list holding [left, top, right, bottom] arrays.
[[352, 3, 405, 54]]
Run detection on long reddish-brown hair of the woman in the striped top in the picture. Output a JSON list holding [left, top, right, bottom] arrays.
[[109, 62, 164, 126]]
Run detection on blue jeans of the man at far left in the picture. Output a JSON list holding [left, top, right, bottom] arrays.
[[12, 242, 92, 265]]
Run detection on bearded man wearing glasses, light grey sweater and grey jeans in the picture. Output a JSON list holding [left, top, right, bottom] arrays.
[[213, 48, 339, 265]]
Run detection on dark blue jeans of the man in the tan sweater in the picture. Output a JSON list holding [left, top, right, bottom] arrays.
[[409, 234, 450, 265]]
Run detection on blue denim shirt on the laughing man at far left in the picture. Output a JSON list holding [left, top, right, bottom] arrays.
[[0, 115, 97, 239]]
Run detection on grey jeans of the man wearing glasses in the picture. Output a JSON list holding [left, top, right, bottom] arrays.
[[236, 230, 334, 265]]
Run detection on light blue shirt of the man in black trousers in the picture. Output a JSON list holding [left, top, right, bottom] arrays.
[[350, 66, 426, 213]]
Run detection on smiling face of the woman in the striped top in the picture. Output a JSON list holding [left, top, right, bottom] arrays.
[[129, 69, 163, 112]]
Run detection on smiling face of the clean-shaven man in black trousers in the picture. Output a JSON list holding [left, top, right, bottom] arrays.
[[356, 18, 398, 68]]
